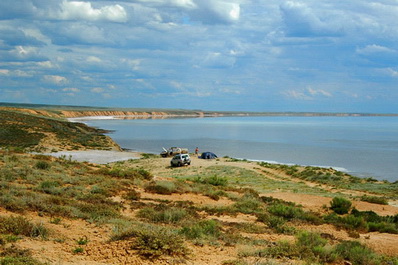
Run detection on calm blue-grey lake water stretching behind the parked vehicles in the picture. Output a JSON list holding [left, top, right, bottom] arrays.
[[84, 117, 398, 181]]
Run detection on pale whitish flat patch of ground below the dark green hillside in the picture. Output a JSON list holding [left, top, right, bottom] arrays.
[[44, 150, 140, 164]]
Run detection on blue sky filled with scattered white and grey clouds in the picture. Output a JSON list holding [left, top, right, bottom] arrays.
[[0, 0, 398, 113]]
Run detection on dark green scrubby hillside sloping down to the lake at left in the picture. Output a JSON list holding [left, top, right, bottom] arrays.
[[0, 110, 119, 151]]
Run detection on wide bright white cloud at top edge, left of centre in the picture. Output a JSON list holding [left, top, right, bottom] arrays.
[[58, 1, 127, 22]]
